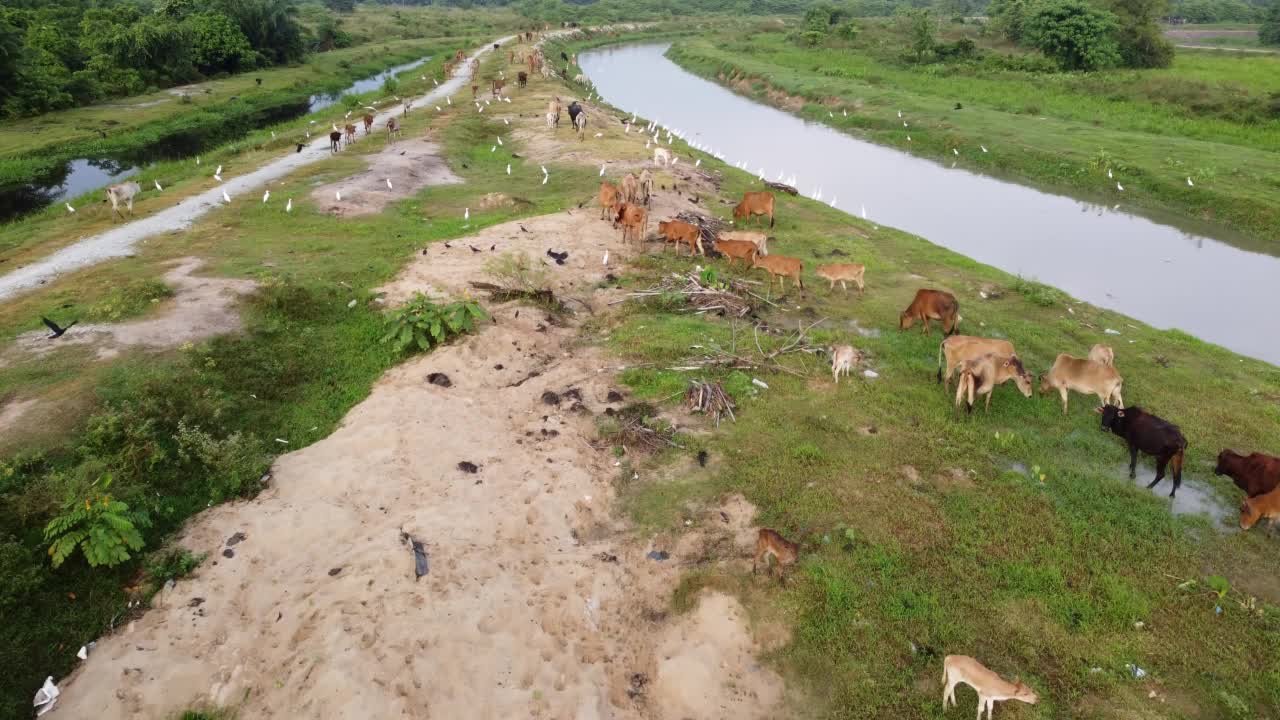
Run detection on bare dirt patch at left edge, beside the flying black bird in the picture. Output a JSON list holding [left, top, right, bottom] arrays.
[[0, 258, 257, 364]]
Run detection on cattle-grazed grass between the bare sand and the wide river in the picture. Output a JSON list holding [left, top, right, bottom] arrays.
[[552, 25, 1280, 719]]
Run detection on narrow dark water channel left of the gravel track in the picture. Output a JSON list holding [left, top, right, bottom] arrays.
[[0, 56, 431, 222]]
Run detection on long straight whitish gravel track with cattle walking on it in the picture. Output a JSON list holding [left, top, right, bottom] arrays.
[[0, 36, 512, 300]]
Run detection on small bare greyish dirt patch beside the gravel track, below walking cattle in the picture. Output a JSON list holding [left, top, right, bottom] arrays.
[[311, 136, 462, 218]]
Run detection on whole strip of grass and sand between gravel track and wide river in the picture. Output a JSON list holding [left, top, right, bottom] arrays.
[[0, 19, 1280, 720]]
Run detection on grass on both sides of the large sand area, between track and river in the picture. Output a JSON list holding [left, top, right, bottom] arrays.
[[0, 19, 1280, 719]]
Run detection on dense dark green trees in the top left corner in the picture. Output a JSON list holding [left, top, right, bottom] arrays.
[[0, 0, 349, 117]]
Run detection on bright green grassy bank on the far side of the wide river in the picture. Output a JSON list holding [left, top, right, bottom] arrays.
[[671, 20, 1280, 254]]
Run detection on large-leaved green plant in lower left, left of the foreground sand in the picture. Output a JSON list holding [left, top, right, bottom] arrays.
[[45, 475, 151, 568]]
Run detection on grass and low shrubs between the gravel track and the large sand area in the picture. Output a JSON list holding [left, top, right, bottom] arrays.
[[0, 35, 595, 717]]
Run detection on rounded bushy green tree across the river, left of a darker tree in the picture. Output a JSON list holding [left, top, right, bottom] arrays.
[[1023, 0, 1120, 70]]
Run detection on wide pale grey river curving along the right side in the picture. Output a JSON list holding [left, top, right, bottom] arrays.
[[579, 44, 1280, 364]]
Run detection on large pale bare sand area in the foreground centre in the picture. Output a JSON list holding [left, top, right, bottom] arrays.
[[54, 193, 782, 720]]
